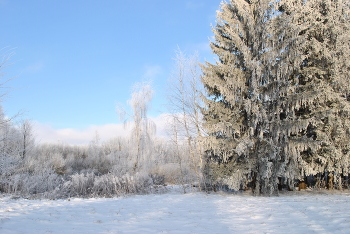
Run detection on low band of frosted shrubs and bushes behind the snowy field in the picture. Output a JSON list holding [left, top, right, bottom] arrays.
[[0, 115, 199, 198]]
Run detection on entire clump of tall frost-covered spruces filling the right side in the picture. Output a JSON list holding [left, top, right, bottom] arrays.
[[202, 0, 349, 194]]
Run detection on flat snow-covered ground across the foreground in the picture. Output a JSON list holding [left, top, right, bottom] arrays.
[[0, 192, 350, 234]]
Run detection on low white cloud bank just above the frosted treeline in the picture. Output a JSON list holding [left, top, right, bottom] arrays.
[[34, 114, 172, 145]]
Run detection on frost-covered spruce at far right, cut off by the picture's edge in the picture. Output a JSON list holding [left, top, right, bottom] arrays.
[[279, 0, 350, 186]]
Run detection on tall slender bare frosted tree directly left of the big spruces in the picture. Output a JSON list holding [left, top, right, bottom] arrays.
[[167, 49, 203, 188]]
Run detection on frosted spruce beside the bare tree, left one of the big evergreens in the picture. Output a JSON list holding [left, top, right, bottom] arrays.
[[202, 0, 284, 194]]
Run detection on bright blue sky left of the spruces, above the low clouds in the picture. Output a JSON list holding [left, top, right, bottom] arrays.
[[0, 0, 221, 143]]
